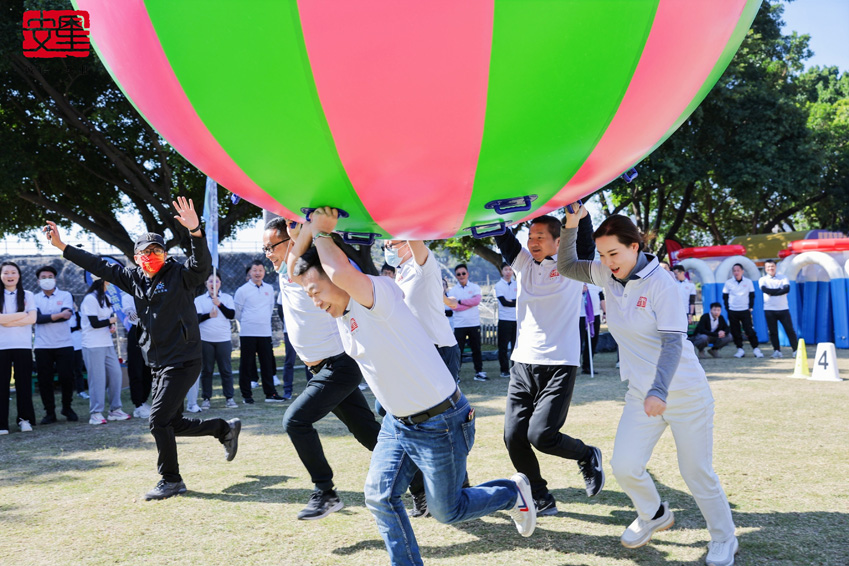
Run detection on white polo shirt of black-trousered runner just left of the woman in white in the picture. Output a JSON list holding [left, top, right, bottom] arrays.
[[510, 248, 584, 366]]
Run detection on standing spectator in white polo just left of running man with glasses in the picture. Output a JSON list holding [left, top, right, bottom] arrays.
[[233, 259, 286, 405]]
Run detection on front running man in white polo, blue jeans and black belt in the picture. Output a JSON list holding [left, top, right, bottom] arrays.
[[292, 208, 536, 565]]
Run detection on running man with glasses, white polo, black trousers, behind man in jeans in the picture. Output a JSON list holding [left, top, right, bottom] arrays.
[[262, 217, 394, 520]]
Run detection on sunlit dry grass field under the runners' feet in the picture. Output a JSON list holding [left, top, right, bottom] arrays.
[[0, 347, 849, 566]]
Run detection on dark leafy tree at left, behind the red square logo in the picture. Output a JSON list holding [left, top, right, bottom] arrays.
[[0, 1, 259, 256]]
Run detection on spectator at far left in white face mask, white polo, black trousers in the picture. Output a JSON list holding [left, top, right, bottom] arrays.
[[35, 265, 79, 424]]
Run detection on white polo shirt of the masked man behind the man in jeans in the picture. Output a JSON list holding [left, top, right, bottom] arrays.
[[395, 254, 457, 348]]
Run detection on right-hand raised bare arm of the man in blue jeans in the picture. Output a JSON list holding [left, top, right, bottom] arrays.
[[304, 206, 374, 309]]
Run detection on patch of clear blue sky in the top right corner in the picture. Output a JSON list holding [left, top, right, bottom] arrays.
[[783, 0, 849, 72]]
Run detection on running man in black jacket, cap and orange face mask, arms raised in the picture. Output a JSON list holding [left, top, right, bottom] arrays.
[[44, 197, 241, 500]]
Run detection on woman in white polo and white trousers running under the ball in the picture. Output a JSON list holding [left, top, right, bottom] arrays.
[[557, 207, 738, 566]]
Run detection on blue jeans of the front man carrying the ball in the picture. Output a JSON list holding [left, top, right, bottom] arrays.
[[365, 396, 519, 566]]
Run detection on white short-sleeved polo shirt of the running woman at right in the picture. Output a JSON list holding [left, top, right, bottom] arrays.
[[591, 256, 707, 395]]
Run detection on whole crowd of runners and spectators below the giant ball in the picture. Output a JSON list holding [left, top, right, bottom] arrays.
[[0, 199, 808, 565]]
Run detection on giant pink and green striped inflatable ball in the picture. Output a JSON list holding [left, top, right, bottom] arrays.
[[74, 0, 761, 241]]
